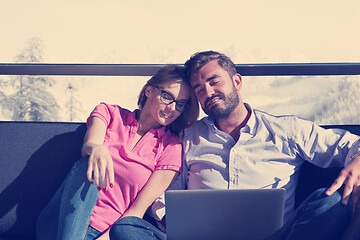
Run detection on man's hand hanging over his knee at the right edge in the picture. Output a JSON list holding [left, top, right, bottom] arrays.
[[326, 156, 360, 212]]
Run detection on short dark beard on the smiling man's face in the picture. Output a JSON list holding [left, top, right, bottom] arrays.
[[203, 88, 240, 120]]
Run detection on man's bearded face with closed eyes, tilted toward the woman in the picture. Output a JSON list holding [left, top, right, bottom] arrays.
[[190, 60, 241, 120]]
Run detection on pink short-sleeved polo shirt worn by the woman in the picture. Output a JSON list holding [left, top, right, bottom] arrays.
[[87, 103, 182, 232]]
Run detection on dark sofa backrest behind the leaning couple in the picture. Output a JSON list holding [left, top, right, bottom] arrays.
[[0, 121, 360, 240]]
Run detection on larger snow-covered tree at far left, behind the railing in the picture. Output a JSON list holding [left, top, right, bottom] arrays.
[[0, 38, 60, 121]]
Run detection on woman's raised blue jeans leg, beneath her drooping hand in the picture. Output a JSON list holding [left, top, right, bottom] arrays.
[[36, 156, 99, 240]]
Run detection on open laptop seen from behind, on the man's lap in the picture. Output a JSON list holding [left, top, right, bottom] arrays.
[[165, 189, 285, 240]]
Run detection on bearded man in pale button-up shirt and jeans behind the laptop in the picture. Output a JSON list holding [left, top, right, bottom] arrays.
[[111, 51, 360, 239]]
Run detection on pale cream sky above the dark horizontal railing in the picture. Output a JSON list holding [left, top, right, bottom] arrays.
[[0, 0, 360, 63]]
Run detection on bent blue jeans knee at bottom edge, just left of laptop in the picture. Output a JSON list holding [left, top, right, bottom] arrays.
[[110, 216, 166, 240]]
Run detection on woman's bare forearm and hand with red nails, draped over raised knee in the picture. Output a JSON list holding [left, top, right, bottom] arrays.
[[81, 117, 114, 189]]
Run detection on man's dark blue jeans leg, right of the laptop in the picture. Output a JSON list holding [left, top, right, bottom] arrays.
[[285, 189, 351, 240]]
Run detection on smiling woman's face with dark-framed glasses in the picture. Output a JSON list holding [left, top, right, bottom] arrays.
[[143, 81, 190, 126]]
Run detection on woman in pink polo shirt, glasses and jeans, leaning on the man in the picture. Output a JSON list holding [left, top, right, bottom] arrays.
[[37, 65, 199, 240]]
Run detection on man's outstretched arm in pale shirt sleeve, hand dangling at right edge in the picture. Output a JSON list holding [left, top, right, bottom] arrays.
[[290, 118, 360, 210]]
